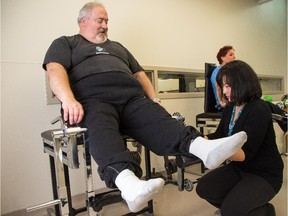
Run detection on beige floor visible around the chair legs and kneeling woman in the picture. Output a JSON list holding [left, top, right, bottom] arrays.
[[3, 156, 288, 216]]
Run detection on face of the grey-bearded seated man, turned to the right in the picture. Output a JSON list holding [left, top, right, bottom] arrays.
[[83, 7, 108, 43]]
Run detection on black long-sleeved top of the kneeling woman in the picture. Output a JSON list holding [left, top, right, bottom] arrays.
[[207, 99, 284, 193]]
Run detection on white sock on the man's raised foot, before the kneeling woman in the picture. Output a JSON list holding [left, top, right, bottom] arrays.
[[189, 131, 247, 169]]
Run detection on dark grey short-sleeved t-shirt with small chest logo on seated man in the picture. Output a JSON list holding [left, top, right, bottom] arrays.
[[43, 34, 143, 85]]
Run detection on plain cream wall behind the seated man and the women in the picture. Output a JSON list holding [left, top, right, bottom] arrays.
[[1, 0, 287, 214]]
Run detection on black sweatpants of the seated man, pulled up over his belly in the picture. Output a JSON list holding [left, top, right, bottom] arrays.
[[77, 74, 200, 188]]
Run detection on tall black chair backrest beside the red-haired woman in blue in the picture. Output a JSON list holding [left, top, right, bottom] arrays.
[[204, 63, 218, 113]]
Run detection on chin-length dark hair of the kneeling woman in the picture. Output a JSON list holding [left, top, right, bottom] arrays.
[[216, 60, 262, 105]]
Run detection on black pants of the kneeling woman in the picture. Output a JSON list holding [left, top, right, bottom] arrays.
[[196, 164, 276, 216]]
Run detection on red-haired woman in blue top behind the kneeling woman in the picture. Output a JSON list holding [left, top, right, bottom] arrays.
[[210, 45, 236, 110]]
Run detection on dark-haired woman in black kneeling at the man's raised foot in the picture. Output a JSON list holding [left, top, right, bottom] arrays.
[[196, 60, 284, 216]]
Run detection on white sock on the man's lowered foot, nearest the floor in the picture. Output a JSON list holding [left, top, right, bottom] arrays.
[[115, 169, 165, 212]]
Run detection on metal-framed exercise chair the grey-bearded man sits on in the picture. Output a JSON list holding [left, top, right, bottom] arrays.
[[27, 117, 153, 216]]
